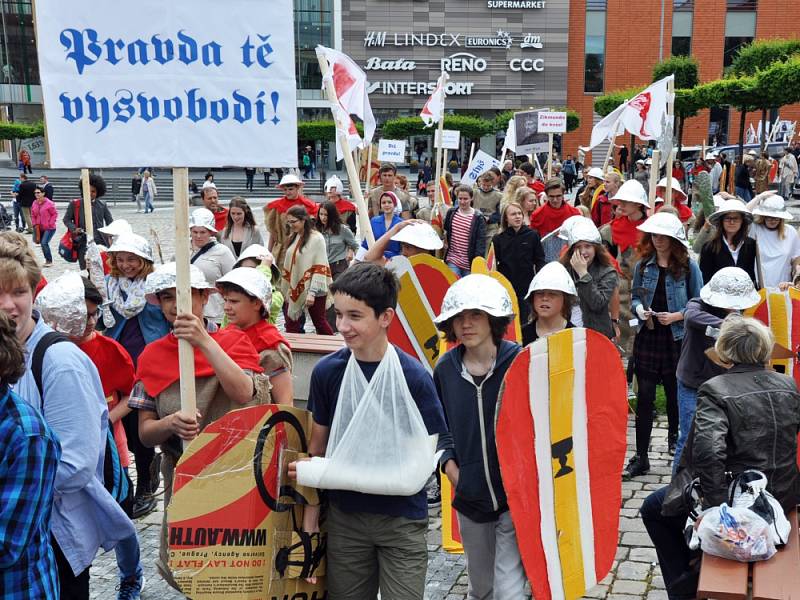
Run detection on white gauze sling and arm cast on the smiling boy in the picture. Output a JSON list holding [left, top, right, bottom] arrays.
[[297, 344, 438, 496]]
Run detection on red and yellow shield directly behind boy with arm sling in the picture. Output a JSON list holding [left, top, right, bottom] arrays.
[[387, 254, 457, 372]]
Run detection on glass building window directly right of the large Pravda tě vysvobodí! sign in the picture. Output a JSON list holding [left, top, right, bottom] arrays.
[[294, 0, 333, 90]]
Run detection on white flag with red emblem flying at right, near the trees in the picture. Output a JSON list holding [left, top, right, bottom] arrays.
[[583, 75, 675, 151]]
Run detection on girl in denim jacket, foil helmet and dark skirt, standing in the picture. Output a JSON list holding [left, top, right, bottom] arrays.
[[623, 212, 703, 478]]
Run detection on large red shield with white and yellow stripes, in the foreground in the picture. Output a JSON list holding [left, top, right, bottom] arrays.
[[497, 328, 628, 600]]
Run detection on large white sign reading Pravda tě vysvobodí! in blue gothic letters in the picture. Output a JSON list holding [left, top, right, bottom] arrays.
[[34, 0, 297, 168]]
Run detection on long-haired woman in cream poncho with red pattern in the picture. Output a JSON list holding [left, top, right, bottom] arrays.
[[281, 206, 332, 335]]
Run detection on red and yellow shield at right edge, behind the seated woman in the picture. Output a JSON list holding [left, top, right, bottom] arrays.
[[744, 287, 800, 384]]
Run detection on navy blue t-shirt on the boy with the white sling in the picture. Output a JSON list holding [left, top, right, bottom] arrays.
[[308, 347, 447, 519]]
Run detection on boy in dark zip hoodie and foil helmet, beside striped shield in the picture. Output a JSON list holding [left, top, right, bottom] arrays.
[[433, 274, 525, 598]]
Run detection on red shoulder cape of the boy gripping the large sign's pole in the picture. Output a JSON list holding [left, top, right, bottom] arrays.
[[136, 327, 264, 397]]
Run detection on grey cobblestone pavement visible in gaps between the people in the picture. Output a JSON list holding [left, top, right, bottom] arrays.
[[31, 204, 670, 600]]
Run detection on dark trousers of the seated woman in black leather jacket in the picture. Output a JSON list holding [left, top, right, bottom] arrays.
[[639, 487, 700, 600]]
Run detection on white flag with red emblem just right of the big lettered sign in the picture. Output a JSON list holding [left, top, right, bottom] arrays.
[[317, 46, 375, 160]]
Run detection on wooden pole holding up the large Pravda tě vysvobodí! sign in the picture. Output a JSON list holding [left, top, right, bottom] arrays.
[[172, 167, 197, 438]]
